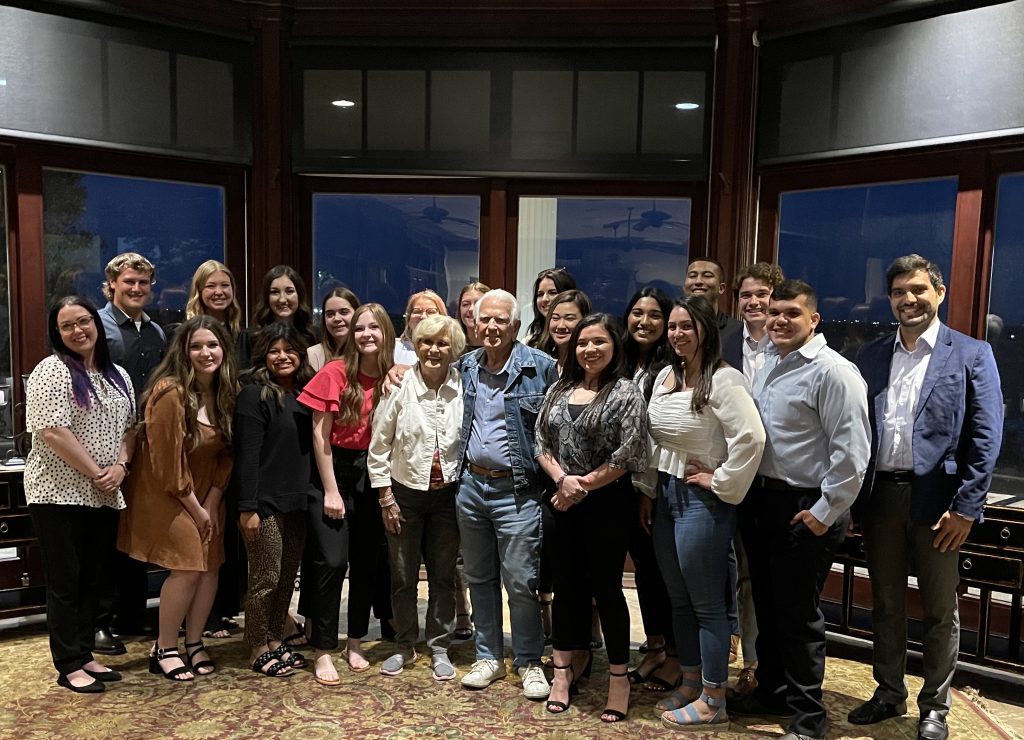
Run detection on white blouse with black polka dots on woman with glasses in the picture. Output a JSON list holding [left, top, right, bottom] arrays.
[[25, 355, 135, 509]]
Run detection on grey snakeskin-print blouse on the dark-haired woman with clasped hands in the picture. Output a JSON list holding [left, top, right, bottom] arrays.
[[537, 378, 647, 475]]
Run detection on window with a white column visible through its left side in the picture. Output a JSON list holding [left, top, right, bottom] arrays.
[[516, 198, 692, 327]]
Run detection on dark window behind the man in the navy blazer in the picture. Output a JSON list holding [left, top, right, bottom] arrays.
[[778, 178, 957, 359]]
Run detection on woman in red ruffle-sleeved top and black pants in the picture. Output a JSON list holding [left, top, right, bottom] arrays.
[[299, 303, 394, 686]]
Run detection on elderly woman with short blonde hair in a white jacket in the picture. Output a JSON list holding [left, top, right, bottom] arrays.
[[367, 315, 466, 681]]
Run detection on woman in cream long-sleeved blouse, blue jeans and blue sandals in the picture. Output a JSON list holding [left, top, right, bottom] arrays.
[[648, 297, 765, 729]]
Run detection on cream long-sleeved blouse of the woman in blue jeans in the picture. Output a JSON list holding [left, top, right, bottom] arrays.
[[638, 365, 765, 504]]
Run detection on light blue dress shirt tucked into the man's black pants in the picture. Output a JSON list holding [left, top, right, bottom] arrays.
[[754, 334, 871, 526]]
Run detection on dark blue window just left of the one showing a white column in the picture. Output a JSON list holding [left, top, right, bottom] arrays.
[[311, 192, 480, 333]]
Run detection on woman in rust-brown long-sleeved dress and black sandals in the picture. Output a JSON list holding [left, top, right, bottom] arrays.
[[118, 315, 238, 681]]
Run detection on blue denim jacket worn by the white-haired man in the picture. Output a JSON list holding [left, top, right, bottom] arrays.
[[459, 342, 558, 489]]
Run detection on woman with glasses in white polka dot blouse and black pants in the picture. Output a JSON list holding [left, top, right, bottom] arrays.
[[25, 296, 135, 694]]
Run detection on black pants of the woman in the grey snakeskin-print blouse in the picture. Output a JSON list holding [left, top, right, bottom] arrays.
[[546, 475, 636, 663]]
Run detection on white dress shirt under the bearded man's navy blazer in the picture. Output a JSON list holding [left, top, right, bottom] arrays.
[[876, 316, 942, 471]]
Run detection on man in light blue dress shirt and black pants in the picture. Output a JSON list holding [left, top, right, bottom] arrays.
[[729, 280, 870, 740]]
